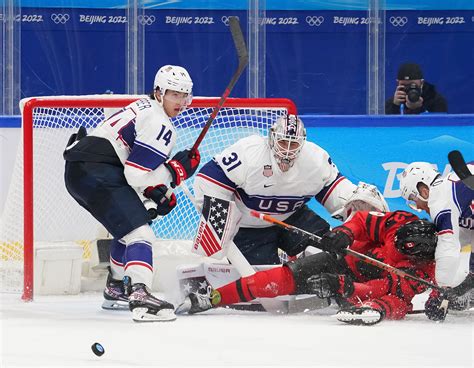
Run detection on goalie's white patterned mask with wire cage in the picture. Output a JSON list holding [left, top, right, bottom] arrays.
[[268, 115, 306, 172]]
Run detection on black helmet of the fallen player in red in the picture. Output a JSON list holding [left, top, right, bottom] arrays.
[[395, 220, 438, 260]]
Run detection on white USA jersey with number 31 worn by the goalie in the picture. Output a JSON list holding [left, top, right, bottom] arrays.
[[194, 135, 356, 227]]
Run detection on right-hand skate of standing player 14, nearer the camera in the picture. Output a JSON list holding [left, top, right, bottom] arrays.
[[128, 284, 176, 322]]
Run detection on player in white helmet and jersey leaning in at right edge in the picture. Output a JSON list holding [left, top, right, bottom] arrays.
[[400, 162, 474, 320]]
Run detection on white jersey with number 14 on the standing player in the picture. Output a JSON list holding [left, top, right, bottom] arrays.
[[90, 98, 176, 188]]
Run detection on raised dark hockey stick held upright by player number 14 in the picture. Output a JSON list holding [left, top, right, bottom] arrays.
[[190, 17, 249, 156]]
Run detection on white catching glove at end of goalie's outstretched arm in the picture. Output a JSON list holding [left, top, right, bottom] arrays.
[[341, 181, 390, 219]]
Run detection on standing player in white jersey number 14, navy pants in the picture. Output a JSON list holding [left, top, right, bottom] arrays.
[[64, 65, 200, 321]]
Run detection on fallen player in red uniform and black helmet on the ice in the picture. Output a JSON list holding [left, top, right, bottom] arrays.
[[181, 211, 437, 325]]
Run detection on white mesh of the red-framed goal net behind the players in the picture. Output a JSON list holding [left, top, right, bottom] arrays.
[[0, 97, 286, 291]]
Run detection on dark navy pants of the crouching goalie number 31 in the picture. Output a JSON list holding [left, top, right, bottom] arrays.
[[234, 205, 329, 265]]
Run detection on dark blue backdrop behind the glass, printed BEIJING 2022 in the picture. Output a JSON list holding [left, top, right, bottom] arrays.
[[12, 1, 474, 114]]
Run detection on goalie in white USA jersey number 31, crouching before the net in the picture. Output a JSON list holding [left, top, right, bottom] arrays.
[[194, 115, 356, 264]]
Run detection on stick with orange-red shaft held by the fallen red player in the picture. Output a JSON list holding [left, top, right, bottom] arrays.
[[251, 211, 446, 294]]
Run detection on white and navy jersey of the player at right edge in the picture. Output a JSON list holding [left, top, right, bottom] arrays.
[[428, 165, 474, 287]]
